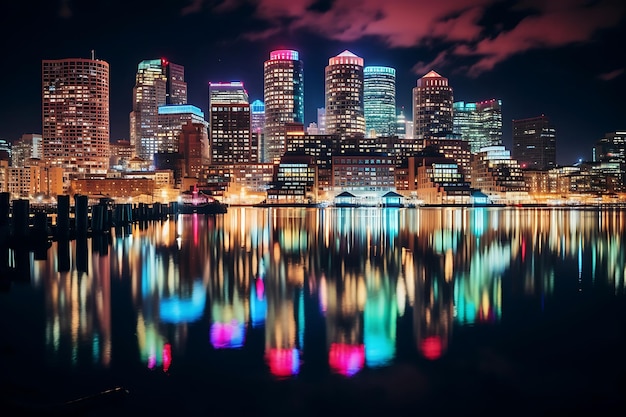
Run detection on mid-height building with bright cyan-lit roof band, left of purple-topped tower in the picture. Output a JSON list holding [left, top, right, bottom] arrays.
[[155, 104, 207, 153]]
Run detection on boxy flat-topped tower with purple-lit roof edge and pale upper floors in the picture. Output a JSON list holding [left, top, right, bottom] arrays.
[[209, 81, 251, 164]]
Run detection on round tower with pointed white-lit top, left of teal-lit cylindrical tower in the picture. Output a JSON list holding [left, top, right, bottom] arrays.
[[325, 51, 365, 137]]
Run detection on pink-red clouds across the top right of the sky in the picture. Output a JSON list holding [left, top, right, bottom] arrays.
[[201, 0, 626, 75]]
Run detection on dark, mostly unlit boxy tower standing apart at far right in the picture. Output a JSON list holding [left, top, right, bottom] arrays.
[[511, 114, 556, 169]]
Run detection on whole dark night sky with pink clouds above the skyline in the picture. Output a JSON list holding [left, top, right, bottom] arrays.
[[0, 0, 626, 164]]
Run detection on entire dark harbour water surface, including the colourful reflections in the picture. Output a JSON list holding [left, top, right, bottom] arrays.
[[0, 208, 626, 416]]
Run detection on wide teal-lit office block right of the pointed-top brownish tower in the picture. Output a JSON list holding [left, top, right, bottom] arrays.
[[453, 98, 502, 154]]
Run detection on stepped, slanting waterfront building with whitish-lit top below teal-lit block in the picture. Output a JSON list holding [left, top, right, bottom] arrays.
[[471, 146, 529, 204]]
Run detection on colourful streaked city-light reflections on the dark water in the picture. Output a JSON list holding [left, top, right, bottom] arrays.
[[9, 208, 626, 378]]
